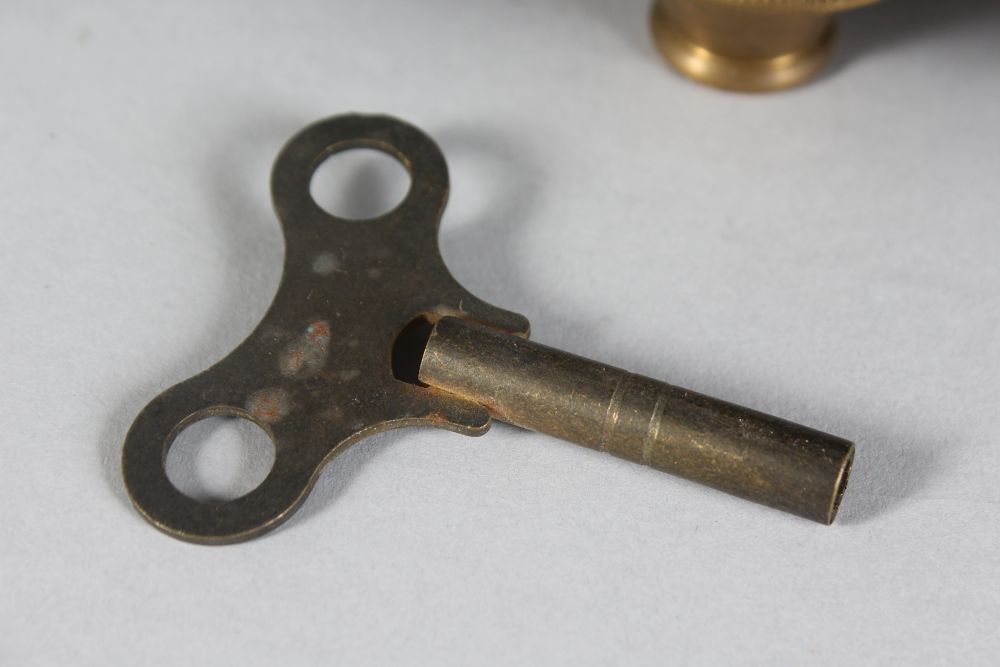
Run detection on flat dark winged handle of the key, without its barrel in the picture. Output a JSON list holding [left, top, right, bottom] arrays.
[[122, 115, 529, 544]]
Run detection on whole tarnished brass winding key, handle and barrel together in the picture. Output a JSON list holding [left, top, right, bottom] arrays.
[[122, 115, 853, 544]]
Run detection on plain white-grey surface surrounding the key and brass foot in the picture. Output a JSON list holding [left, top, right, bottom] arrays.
[[0, 0, 1000, 665]]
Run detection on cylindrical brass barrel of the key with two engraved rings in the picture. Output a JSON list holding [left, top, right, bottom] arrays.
[[419, 317, 854, 524]]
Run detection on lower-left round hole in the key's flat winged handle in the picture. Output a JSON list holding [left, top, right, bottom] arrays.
[[165, 416, 275, 503]]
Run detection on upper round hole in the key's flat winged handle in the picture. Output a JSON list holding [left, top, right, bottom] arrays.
[[309, 147, 411, 221]]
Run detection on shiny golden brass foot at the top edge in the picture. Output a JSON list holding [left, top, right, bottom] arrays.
[[652, 0, 877, 92]]
